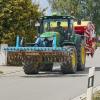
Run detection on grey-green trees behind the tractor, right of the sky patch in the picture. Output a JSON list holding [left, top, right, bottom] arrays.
[[48, 0, 100, 33]]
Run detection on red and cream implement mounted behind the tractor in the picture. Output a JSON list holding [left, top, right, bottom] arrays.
[[74, 21, 96, 57]]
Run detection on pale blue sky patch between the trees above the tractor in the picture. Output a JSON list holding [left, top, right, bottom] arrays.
[[33, 0, 51, 15]]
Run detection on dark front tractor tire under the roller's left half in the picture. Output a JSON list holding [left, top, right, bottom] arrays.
[[23, 63, 38, 75]]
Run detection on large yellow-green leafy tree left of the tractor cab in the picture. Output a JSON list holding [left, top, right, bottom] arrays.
[[0, 0, 41, 44]]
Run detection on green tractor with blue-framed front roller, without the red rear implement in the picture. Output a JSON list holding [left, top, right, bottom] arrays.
[[5, 15, 86, 75]]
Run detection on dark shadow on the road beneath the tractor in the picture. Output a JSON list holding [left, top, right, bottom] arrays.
[[21, 67, 100, 78]]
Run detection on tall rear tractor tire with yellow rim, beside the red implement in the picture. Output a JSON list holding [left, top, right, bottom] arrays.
[[76, 42, 86, 71]]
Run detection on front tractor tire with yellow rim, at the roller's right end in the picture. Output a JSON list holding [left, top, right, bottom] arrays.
[[61, 48, 77, 74]]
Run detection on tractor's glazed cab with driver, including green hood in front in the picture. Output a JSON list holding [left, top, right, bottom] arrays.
[[36, 15, 74, 47]]
